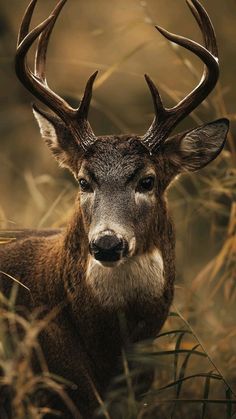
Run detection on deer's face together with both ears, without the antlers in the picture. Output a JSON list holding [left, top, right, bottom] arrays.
[[34, 108, 228, 267]]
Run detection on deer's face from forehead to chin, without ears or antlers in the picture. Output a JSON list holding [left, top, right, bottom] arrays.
[[78, 137, 159, 265]]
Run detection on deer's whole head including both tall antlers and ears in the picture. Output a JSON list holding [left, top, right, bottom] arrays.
[[15, 0, 229, 266]]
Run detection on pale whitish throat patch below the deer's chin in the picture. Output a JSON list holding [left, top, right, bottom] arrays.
[[86, 249, 165, 308]]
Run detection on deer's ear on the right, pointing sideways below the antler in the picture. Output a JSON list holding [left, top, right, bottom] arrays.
[[164, 118, 229, 172]]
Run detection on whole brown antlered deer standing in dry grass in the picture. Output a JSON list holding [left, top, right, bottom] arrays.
[[0, 0, 229, 418]]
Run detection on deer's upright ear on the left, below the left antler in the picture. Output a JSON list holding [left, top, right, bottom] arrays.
[[33, 104, 81, 174]]
